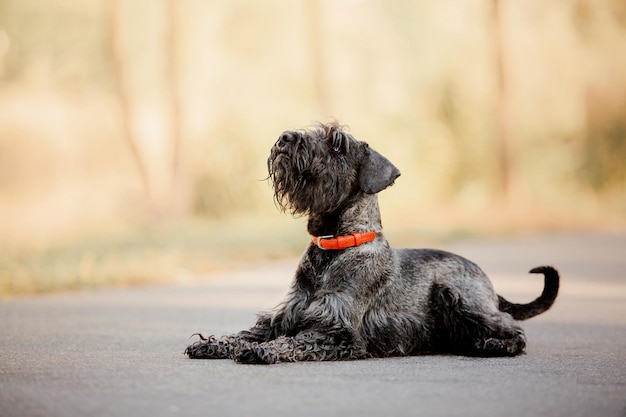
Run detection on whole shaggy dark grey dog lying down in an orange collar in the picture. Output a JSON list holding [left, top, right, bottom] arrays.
[[185, 122, 559, 364]]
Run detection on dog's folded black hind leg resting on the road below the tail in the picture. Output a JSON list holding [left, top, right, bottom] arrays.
[[433, 287, 526, 357]]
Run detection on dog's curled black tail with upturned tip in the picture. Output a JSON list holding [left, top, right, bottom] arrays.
[[498, 266, 559, 320]]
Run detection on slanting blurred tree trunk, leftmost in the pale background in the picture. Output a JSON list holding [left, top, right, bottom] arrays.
[[107, 0, 151, 203]]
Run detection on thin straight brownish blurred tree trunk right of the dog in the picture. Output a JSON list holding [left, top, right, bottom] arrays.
[[493, 0, 511, 201]]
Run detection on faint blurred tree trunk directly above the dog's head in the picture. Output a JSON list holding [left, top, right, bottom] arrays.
[[305, 0, 332, 117]]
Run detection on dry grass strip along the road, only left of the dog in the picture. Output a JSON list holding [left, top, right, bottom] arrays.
[[0, 214, 306, 296]]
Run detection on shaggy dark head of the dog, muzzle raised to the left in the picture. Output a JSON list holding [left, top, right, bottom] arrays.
[[267, 123, 400, 214]]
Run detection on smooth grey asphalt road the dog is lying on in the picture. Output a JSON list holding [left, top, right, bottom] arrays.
[[0, 233, 626, 417]]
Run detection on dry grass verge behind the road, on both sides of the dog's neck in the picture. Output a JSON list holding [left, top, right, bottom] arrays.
[[0, 202, 622, 297]]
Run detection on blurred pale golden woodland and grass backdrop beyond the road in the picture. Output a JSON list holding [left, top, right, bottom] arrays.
[[0, 0, 626, 295]]
